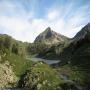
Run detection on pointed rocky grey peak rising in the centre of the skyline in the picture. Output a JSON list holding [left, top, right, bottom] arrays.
[[34, 27, 68, 44]]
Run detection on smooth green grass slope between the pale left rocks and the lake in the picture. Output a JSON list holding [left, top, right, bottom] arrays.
[[4, 54, 33, 77]]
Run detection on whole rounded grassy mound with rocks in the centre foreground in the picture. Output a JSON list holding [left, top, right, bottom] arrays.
[[20, 62, 65, 90]]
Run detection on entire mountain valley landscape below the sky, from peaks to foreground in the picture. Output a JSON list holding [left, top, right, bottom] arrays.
[[0, 23, 90, 90]]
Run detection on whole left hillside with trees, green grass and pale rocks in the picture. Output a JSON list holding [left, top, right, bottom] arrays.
[[0, 34, 33, 87]]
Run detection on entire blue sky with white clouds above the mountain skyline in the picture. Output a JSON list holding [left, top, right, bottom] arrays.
[[0, 0, 90, 42]]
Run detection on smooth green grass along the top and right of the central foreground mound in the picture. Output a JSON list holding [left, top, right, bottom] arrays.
[[32, 63, 59, 83]]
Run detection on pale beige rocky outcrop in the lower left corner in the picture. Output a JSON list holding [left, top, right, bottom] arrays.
[[0, 61, 17, 88]]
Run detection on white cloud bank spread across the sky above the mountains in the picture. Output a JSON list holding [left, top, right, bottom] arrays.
[[0, 2, 90, 42]]
